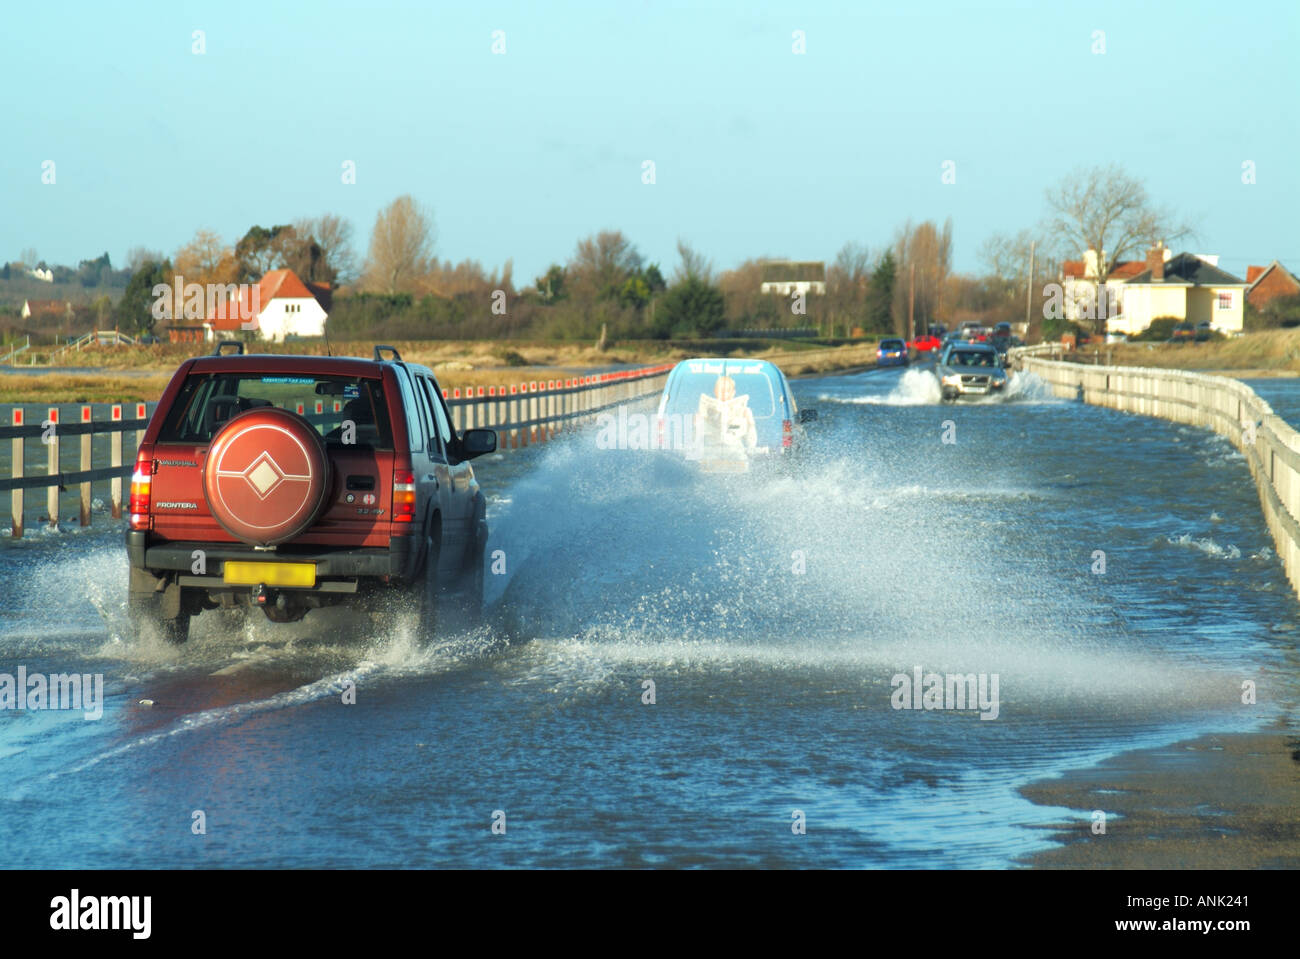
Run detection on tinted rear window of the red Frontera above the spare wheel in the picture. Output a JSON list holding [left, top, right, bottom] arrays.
[[159, 373, 393, 450]]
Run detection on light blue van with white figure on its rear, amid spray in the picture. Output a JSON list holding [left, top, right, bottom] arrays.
[[657, 356, 811, 473]]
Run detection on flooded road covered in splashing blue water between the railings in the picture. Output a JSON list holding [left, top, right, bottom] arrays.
[[0, 369, 1300, 868]]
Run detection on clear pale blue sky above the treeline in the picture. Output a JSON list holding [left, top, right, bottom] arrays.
[[0, 0, 1300, 283]]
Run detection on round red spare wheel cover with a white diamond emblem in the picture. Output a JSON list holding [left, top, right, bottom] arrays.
[[203, 407, 329, 546]]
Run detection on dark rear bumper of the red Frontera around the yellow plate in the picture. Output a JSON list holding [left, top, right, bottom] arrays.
[[126, 529, 415, 582]]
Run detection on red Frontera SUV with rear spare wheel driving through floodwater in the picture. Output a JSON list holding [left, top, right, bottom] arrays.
[[126, 343, 497, 643]]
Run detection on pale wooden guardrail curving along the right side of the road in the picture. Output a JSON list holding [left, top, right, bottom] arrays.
[[1011, 347, 1300, 594]]
